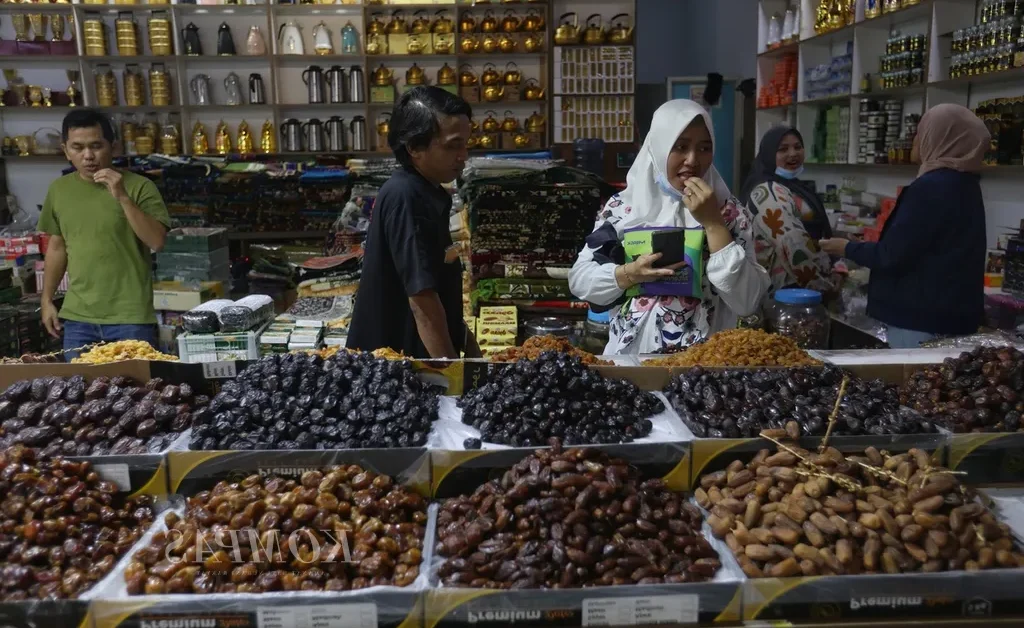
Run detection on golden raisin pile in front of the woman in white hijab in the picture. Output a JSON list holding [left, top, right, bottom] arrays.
[[644, 329, 821, 367]]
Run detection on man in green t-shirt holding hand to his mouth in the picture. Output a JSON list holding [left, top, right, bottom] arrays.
[[39, 109, 170, 360]]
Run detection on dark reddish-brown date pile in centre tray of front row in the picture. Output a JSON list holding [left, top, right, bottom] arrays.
[[437, 441, 721, 589]]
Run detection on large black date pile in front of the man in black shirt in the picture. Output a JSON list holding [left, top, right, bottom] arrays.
[[190, 351, 438, 450]]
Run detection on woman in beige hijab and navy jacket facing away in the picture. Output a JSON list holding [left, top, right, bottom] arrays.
[[820, 104, 991, 348]]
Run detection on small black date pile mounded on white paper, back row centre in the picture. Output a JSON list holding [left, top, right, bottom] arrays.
[[459, 351, 665, 449]]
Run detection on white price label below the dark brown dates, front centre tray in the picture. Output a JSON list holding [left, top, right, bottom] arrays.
[[583, 595, 700, 626]]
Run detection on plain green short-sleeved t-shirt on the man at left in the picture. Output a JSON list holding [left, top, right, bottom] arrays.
[[39, 170, 170, 325]]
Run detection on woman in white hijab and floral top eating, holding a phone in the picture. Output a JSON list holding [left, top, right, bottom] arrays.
[[569, 99, 769, 354]]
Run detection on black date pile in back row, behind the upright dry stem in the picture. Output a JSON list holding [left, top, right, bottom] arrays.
[[665, 366, 936, 438]]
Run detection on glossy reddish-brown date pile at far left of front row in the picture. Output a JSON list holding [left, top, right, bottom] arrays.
[[0, 447, 154, 601]]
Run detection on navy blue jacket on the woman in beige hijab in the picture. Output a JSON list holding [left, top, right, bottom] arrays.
[[846, 168, 986, 335]]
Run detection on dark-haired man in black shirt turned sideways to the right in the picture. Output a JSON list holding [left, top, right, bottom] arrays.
[[348, 87, 472, 359]]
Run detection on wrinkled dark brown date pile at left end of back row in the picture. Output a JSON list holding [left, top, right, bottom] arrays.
[[0, 375, 209, 457]]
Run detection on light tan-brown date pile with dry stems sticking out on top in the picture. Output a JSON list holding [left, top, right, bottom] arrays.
[[694, 447, 1024, 578]]
